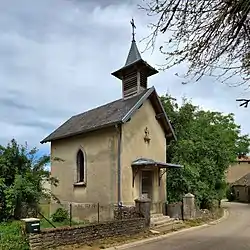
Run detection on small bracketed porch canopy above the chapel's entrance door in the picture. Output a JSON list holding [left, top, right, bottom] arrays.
[[131, 158, 183, 186]]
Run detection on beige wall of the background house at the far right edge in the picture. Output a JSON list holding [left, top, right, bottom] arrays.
[[226, 162, 250, 183]]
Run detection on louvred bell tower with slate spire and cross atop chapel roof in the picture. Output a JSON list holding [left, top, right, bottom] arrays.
[[112, 19, 158, 98]]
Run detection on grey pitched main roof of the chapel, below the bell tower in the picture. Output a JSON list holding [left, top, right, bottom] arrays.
[[41, 87, 176, 143]]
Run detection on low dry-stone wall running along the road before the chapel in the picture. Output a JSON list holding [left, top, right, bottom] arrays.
[[29, 218, 146, 250]]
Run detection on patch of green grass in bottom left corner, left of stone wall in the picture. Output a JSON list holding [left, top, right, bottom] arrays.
[[0, 221, 29, 250]]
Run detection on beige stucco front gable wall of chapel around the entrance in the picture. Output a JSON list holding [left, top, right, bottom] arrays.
[[121, 100, 166, 204]]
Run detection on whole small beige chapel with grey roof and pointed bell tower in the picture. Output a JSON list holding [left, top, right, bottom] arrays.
[[41, 22, 180, 221]]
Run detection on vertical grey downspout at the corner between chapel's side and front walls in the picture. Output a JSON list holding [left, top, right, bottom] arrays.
[[115, 124, 122, 206]]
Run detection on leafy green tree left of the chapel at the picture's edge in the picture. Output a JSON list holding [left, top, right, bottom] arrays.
[[0, 139, 58, 220]]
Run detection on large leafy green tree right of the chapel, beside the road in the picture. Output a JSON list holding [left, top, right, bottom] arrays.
[[161, 96, 250, 208]]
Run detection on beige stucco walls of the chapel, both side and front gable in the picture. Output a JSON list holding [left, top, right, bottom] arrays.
[[51, 97, 166, 215]]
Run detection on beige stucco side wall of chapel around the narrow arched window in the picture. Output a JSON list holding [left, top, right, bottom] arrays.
[[51, 127, 117, 208]]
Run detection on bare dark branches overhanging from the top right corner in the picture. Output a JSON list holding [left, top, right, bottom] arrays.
[[140, 0, 250, 85]]
